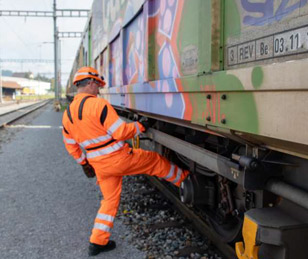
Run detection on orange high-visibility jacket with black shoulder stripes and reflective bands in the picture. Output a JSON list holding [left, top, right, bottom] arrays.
[[62, 93, 145, 165]]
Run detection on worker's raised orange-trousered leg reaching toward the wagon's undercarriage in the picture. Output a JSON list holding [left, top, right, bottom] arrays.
[[121, 149, 189, 186]]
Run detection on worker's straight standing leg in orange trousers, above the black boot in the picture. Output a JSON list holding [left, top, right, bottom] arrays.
[[90, 176, 122, 245]]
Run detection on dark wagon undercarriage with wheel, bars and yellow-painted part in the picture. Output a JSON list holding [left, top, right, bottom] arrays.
[[118, 108, 308, 259]]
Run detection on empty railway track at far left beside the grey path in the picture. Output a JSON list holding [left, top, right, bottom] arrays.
[[0, 100, 50, 128]]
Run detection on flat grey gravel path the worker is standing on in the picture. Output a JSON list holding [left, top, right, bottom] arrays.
[[0, 105, 145, 259]]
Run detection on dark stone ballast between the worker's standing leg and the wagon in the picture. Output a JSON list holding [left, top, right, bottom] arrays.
[[117, 176, 232, 259]]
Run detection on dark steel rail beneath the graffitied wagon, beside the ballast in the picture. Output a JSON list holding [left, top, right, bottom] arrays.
[[147, 177, 237, 259]]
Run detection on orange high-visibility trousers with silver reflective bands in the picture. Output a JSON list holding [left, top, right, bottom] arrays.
[[90, 145, 189, 245]]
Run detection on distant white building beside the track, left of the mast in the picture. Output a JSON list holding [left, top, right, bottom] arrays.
[[2, 76, 51, 95]]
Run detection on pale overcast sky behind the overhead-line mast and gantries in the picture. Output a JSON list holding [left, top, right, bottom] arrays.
[[0, 0, 93, 85]]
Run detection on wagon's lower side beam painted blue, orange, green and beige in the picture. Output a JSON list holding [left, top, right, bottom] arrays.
[[104, 60, 308, 155]]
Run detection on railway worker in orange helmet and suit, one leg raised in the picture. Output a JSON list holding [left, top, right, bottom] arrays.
[[63, 67, 189, 256]]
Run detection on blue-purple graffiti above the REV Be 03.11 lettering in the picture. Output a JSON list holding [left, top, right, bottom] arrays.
[[241, 0, 308, 26]]
